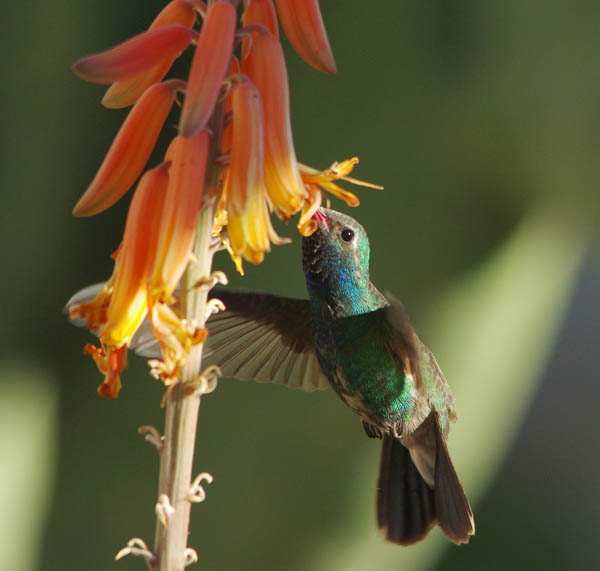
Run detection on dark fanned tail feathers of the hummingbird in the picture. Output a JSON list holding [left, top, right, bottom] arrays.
[[377, 412, 475, 545]]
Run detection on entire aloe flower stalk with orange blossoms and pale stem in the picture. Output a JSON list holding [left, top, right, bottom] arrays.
[[69, 0, 376, 571]]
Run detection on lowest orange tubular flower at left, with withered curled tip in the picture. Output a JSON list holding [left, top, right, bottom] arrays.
[[70, 163, 169, 398]]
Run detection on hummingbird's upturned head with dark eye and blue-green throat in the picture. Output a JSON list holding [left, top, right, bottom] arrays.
[[302, 208, 370, 309]]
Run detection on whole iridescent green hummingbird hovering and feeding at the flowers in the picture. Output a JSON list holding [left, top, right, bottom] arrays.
[[67, 208, 475, 545]]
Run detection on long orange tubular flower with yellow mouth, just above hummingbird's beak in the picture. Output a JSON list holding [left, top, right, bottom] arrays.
[[242, 31, 307, 220]]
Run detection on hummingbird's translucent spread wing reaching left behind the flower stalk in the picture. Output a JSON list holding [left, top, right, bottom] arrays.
[[66, 283, 330, 391]]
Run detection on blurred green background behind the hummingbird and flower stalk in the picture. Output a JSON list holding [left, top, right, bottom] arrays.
[[0, 0, 600, 571]]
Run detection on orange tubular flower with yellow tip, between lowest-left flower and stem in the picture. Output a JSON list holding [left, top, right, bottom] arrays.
[[150, 130, 210, 301]]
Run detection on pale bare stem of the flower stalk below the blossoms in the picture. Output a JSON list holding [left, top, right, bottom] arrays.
[[154, 204, 213, 571]]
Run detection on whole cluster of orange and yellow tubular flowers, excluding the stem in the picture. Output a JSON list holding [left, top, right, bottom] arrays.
[[70, 0, 375, 397]]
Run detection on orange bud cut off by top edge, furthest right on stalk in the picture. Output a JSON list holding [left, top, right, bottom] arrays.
[[275, 0, 336, 73]]
